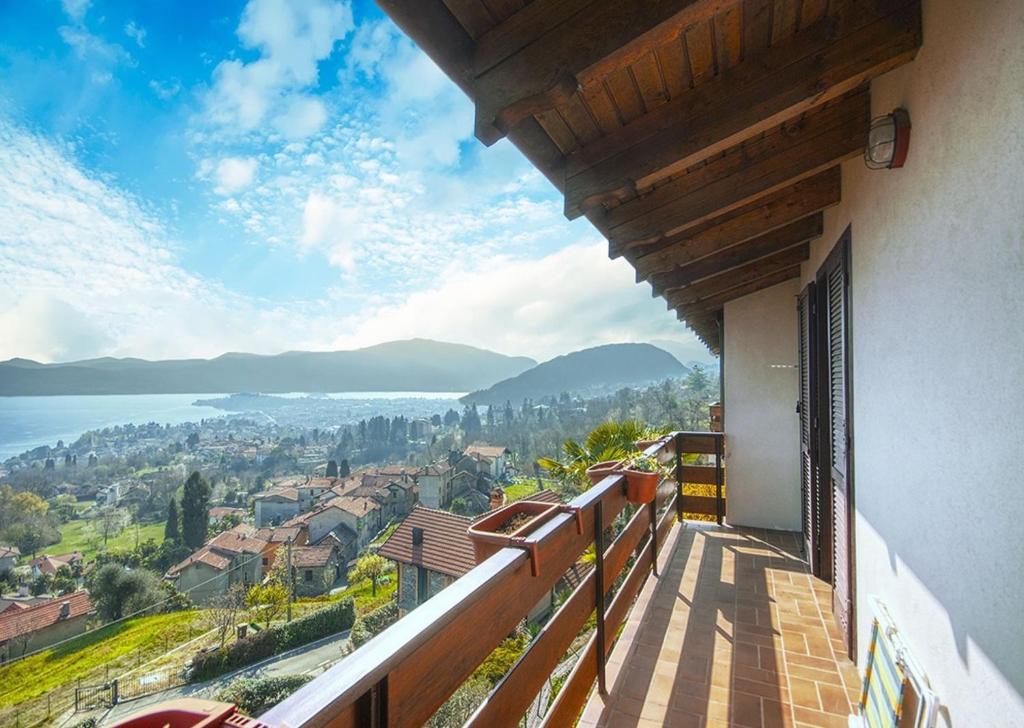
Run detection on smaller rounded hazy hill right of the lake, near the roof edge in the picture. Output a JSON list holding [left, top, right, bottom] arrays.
[[462, 344, 688, 404]]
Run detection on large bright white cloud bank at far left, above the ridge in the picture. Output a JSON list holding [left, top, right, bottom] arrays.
[[0, 117, 326, 359]]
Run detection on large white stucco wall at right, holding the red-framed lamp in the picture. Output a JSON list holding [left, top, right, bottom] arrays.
[[794, 0, 1024, 728]]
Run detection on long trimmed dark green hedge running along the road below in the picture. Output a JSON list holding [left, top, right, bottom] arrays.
[[189, 599, 355, 682]]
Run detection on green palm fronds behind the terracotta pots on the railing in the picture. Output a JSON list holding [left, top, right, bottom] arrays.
[[537, 420, 665, 494]]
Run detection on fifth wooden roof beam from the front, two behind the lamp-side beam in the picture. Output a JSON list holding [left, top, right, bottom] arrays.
[[650, 212, 824, 296]]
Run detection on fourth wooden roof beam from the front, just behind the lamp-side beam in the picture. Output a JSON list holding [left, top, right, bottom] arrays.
[[625, 167, 842, 274]]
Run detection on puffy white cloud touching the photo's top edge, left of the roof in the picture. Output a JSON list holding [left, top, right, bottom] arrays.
[[198, 0, 353, 136]]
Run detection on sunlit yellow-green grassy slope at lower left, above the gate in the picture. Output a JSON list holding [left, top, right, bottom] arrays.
[[0, 611, 204, 725]]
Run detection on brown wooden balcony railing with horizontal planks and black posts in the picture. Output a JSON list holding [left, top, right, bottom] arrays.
[[253, 432, 725, 728]]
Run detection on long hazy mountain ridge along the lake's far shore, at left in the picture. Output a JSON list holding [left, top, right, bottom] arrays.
[[0, 339, 537, 395]]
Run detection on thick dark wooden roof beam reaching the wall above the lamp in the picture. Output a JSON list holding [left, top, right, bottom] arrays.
[[565, 0, 922, 218]]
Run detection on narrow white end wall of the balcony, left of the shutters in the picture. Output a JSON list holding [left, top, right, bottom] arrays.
[[723, 281, 800, 530]]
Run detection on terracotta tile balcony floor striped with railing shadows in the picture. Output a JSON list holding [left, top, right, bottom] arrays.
[[580, 521, 860, 728]]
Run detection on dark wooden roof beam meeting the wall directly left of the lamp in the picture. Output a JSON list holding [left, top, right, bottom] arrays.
[[588, 88, 870, 252]]
